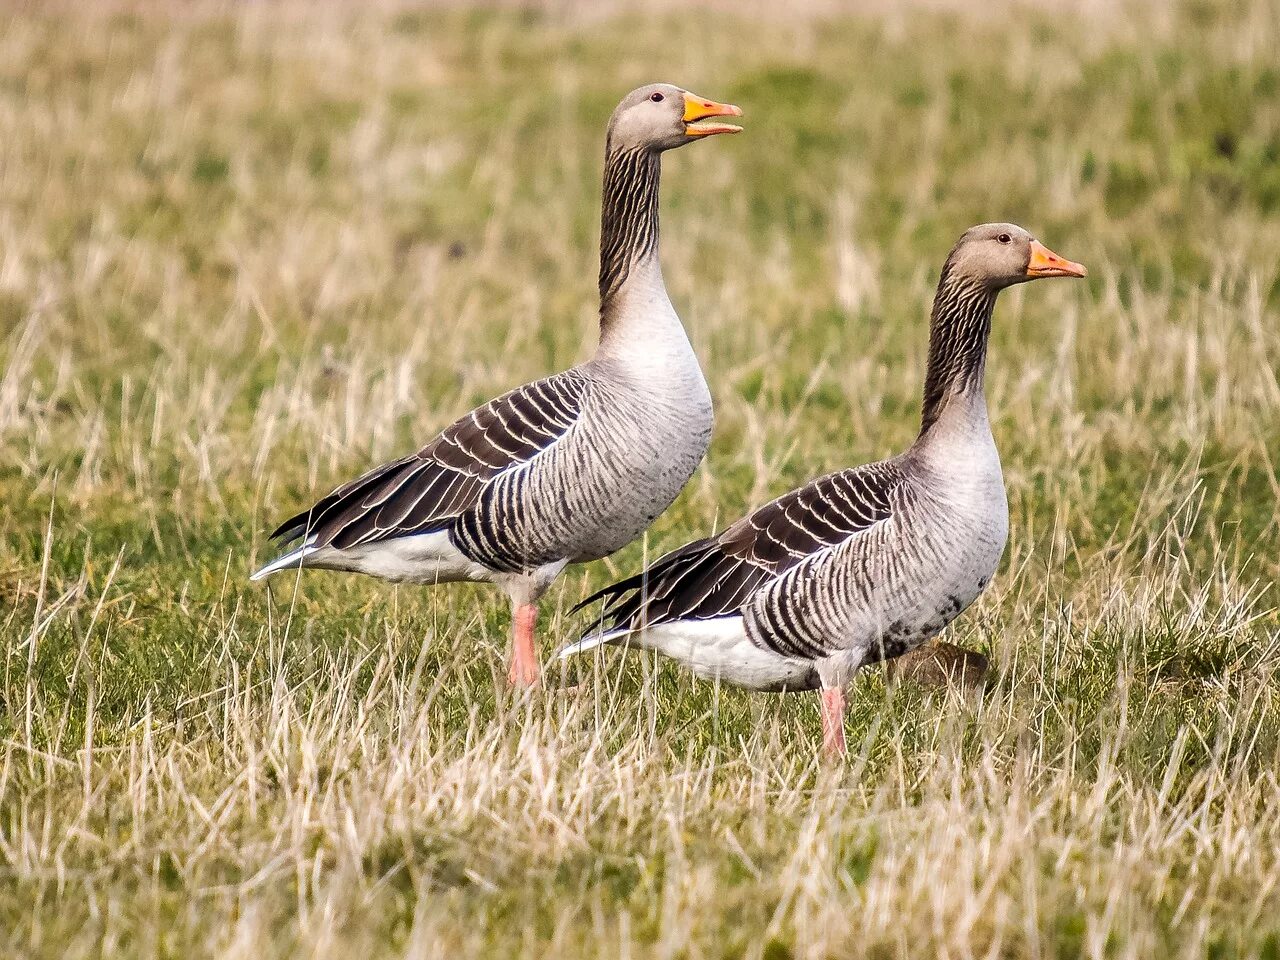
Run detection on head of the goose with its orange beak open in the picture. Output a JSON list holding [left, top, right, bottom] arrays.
[[608, 83, 742, 152]]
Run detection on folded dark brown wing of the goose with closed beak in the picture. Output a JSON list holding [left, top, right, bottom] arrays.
[[579, 462, 900, 635]]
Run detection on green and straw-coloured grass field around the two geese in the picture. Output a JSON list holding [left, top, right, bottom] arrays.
[[0, 0, 1280, 960]]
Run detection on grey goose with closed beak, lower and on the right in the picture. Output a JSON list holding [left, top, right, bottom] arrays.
[[558, 223, 1085, 754]]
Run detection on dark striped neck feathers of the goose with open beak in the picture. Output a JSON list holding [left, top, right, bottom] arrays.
[[600, 146, 660, 325]]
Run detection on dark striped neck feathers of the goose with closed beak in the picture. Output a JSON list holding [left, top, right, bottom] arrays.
[[920, 259, 1000, 436]]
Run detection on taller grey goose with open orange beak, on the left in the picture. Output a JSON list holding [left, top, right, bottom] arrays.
[[251, 83, 742, 686]]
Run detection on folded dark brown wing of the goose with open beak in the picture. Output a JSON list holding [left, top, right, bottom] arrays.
[[271, 370, 590, 549]]
